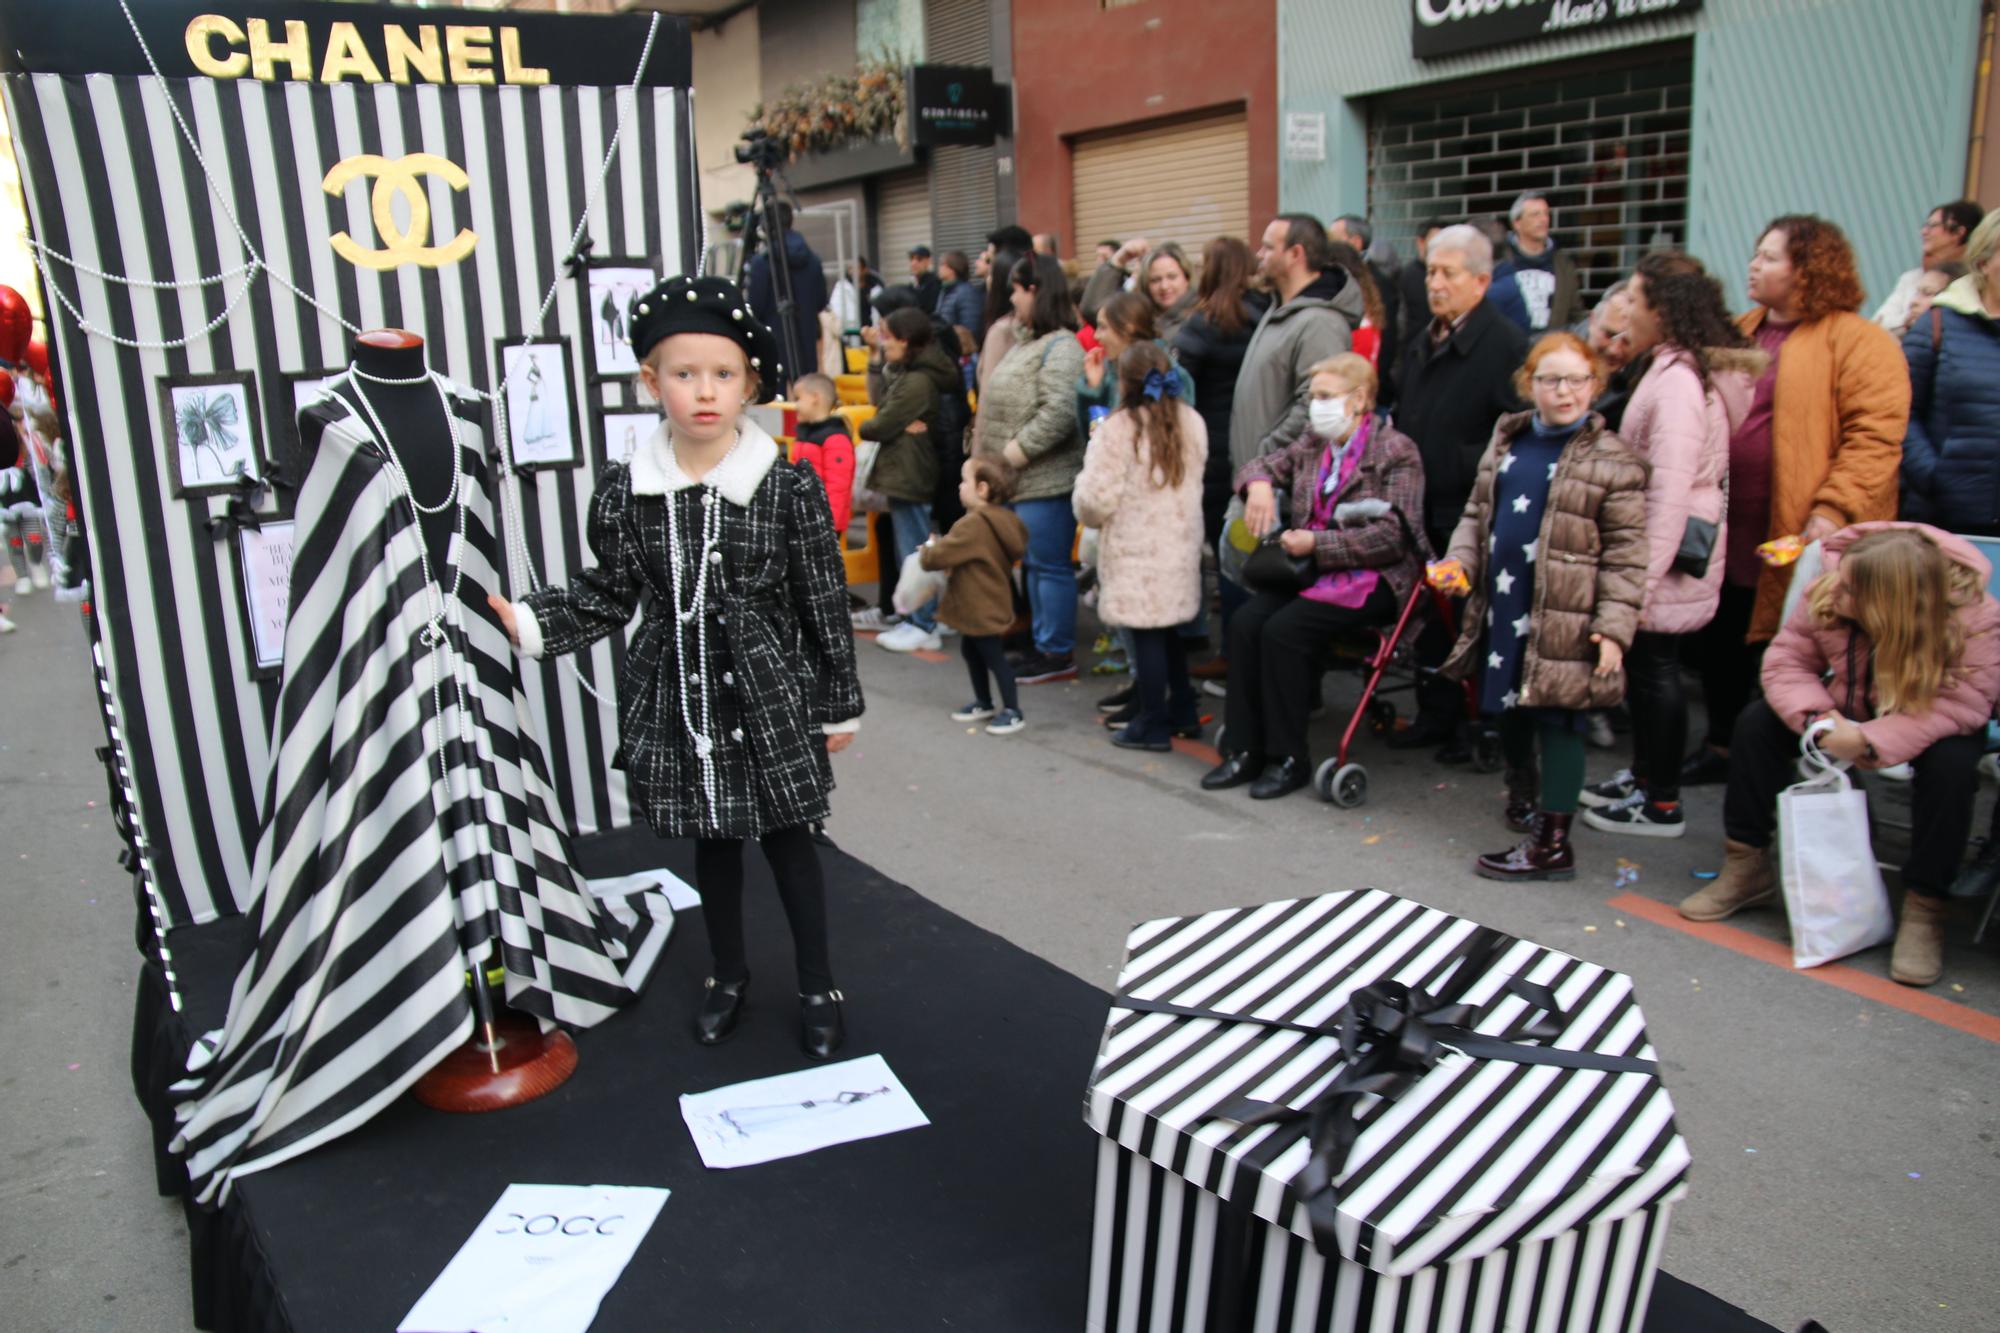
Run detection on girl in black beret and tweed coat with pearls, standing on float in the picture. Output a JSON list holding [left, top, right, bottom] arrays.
[[492, 278, 862, 1059]]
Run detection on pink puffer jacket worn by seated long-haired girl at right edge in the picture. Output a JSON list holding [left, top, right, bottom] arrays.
[[1764, 522, 2000, 767]]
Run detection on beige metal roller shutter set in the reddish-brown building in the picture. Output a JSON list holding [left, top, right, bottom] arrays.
[[1070, 110, 1250, 258]]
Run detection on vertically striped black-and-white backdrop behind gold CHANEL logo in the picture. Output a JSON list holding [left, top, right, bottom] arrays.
[[4, 4, 700, 925]]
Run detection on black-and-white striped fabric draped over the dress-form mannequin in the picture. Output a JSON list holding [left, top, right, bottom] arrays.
[[174, 394, 672, 1203]]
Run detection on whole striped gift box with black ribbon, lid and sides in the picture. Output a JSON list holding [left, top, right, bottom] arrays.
[[1086, 889, 1690, 1333]]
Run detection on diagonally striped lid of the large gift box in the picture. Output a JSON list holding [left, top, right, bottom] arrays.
[[1086, 889, 1688, 1277]]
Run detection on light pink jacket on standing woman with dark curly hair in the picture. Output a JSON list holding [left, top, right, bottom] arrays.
[[1618, 346, 1770, 634]]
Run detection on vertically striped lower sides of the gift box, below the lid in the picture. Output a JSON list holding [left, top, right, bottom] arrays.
[[1084, 1139, 1672, 1333]]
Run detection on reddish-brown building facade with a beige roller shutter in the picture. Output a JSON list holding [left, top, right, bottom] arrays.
[[1012, 0, 1278, 266]]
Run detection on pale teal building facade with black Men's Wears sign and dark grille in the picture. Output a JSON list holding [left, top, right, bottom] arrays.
[[1276, 0, 2000, 308]]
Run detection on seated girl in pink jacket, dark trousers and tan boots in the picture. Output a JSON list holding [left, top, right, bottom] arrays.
[[1680, 522, 2000, 987]]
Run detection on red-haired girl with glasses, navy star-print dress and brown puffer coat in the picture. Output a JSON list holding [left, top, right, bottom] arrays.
[[1434, 332, 1648, 879]]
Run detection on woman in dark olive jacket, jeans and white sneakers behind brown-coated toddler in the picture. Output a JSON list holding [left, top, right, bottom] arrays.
[[860, 306, 958, 652]]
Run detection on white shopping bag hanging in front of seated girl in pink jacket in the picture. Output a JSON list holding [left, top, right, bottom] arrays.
[[1778, 723, 1896, 967]]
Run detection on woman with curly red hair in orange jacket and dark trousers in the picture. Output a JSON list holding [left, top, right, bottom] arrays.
[[1682, 214, 1910, 787]]
